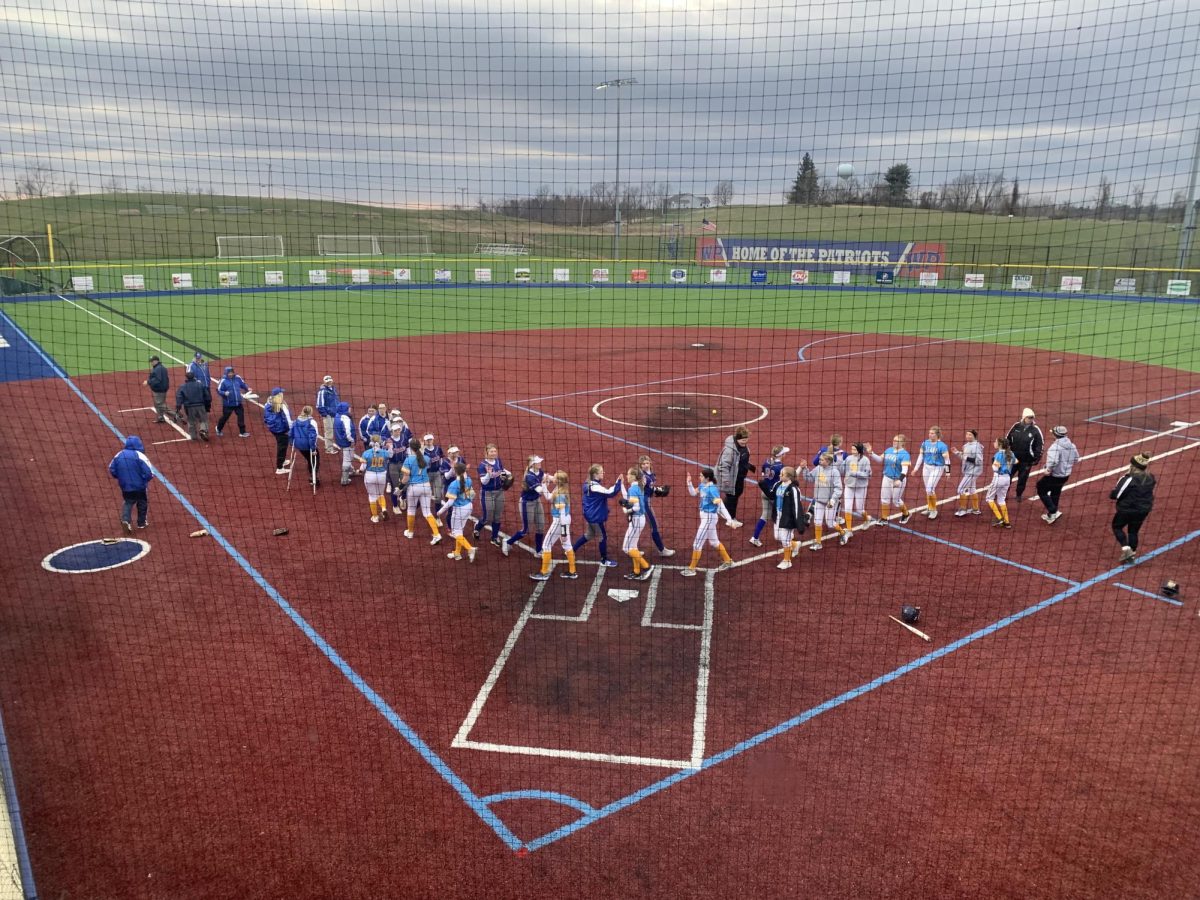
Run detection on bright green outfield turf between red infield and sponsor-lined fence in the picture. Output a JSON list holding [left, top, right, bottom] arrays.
[[2, 287, 1200, 374]]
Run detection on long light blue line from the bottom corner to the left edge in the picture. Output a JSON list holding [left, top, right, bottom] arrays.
[[0, 310, 522, 850]]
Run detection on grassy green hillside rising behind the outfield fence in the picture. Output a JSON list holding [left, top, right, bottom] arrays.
[[0, 193, 1200, 269]]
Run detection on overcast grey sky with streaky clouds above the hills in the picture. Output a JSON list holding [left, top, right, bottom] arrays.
[[0, 0, 1200, 206]]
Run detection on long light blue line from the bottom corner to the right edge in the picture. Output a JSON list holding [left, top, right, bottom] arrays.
[[526, 520, 1200, 851]]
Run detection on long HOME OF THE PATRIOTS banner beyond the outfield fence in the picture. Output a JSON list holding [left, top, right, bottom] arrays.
[[696, 238, 946, 277]]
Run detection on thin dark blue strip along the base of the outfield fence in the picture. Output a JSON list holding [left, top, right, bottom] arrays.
[[4, 282, 1200, 306]]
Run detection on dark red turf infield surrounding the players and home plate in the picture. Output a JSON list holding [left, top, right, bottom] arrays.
[[0, 330, 1200, 896]]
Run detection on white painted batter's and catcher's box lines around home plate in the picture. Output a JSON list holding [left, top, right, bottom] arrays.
[[450, 565, 715, 772]]
